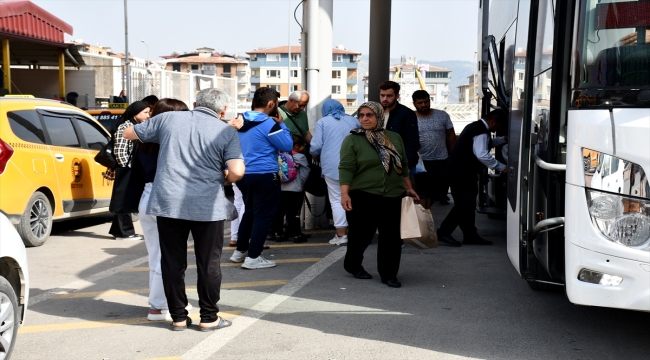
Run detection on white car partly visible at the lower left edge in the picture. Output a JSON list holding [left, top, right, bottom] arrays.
[[0, 213, 29, 359]]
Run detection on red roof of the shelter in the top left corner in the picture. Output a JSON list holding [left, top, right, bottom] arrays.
[[0, 0, 72, 44]]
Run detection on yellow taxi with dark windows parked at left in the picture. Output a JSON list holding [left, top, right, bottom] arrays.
[[0, 97, 113, 246]]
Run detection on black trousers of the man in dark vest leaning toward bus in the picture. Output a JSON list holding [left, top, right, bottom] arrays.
[[438, 173, 478, 239]]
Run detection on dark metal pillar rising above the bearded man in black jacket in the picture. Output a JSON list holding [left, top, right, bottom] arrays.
[[368, 0, 392, 101]]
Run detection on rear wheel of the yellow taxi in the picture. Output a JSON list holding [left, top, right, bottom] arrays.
[[18, 191, 52, 247]]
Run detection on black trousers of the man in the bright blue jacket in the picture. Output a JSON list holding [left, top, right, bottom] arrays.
[[237, 172, 281, 259]]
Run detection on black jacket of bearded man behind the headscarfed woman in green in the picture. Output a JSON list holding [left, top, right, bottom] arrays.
[[384, 103, 420, 168]]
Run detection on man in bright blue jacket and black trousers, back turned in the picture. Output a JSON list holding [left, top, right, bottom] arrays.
[[230, 87, 293, 269]]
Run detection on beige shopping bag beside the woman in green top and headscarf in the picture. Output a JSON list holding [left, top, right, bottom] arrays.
[[400, 196, 438, 249]]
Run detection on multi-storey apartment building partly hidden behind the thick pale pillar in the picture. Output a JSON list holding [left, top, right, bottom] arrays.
[[246, 46, 361, 106]]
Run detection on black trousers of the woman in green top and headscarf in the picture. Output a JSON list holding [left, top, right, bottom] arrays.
[[343, 190, 402, 280]]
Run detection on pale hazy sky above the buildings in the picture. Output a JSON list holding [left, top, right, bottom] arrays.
[[32, 0, 478, 61]]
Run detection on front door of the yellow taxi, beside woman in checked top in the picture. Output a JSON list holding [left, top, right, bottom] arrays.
[[75, 115, 113, 209]]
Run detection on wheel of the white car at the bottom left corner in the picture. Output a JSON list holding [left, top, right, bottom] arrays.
[[0, 276, 20, 359]]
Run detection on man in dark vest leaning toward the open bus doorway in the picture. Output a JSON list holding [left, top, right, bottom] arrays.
[[438, 110, 508, 246]]
